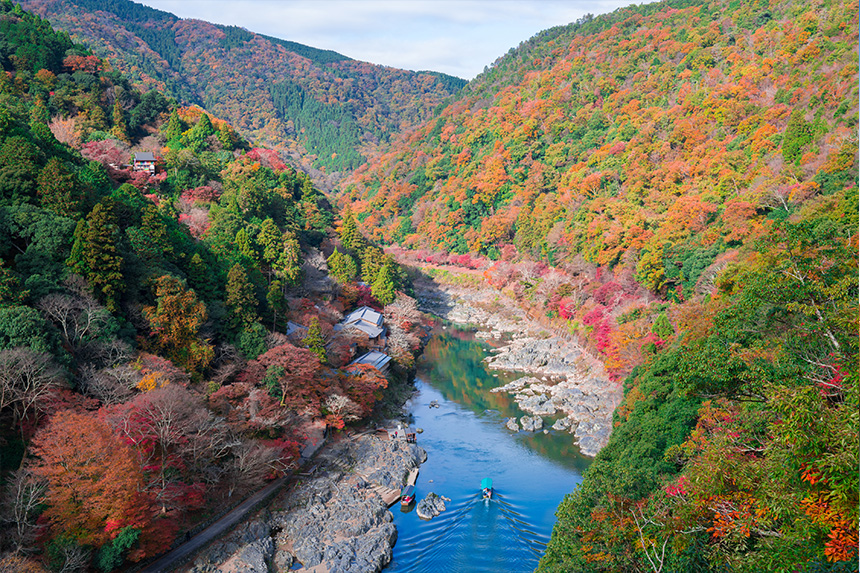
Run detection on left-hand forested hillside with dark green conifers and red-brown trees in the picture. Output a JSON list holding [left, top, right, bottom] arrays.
[[0, 0, 419, 571]]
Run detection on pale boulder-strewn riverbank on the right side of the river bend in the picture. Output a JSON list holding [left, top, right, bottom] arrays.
[[416, 283, 623, 456]]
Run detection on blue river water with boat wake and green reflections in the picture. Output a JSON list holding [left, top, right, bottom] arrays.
[[385, 328, 589, 573]]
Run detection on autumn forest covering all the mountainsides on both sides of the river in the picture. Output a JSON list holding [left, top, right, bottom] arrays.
[[0, 0, 860, 572]]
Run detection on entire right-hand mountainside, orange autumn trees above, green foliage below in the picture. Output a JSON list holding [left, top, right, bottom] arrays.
[[341, 0, 858, 571]]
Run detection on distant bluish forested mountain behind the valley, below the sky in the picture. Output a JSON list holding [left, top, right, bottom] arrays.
[[16, 0, 465, 182]]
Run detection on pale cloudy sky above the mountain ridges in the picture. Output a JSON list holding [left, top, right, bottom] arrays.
[[137, 0, 631, 80]]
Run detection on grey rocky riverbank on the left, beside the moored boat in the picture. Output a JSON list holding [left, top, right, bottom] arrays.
[[191, 434, 427, 573]]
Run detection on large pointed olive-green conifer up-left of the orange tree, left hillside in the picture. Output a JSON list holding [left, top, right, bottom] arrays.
[[66, 197, 125, 312]]
